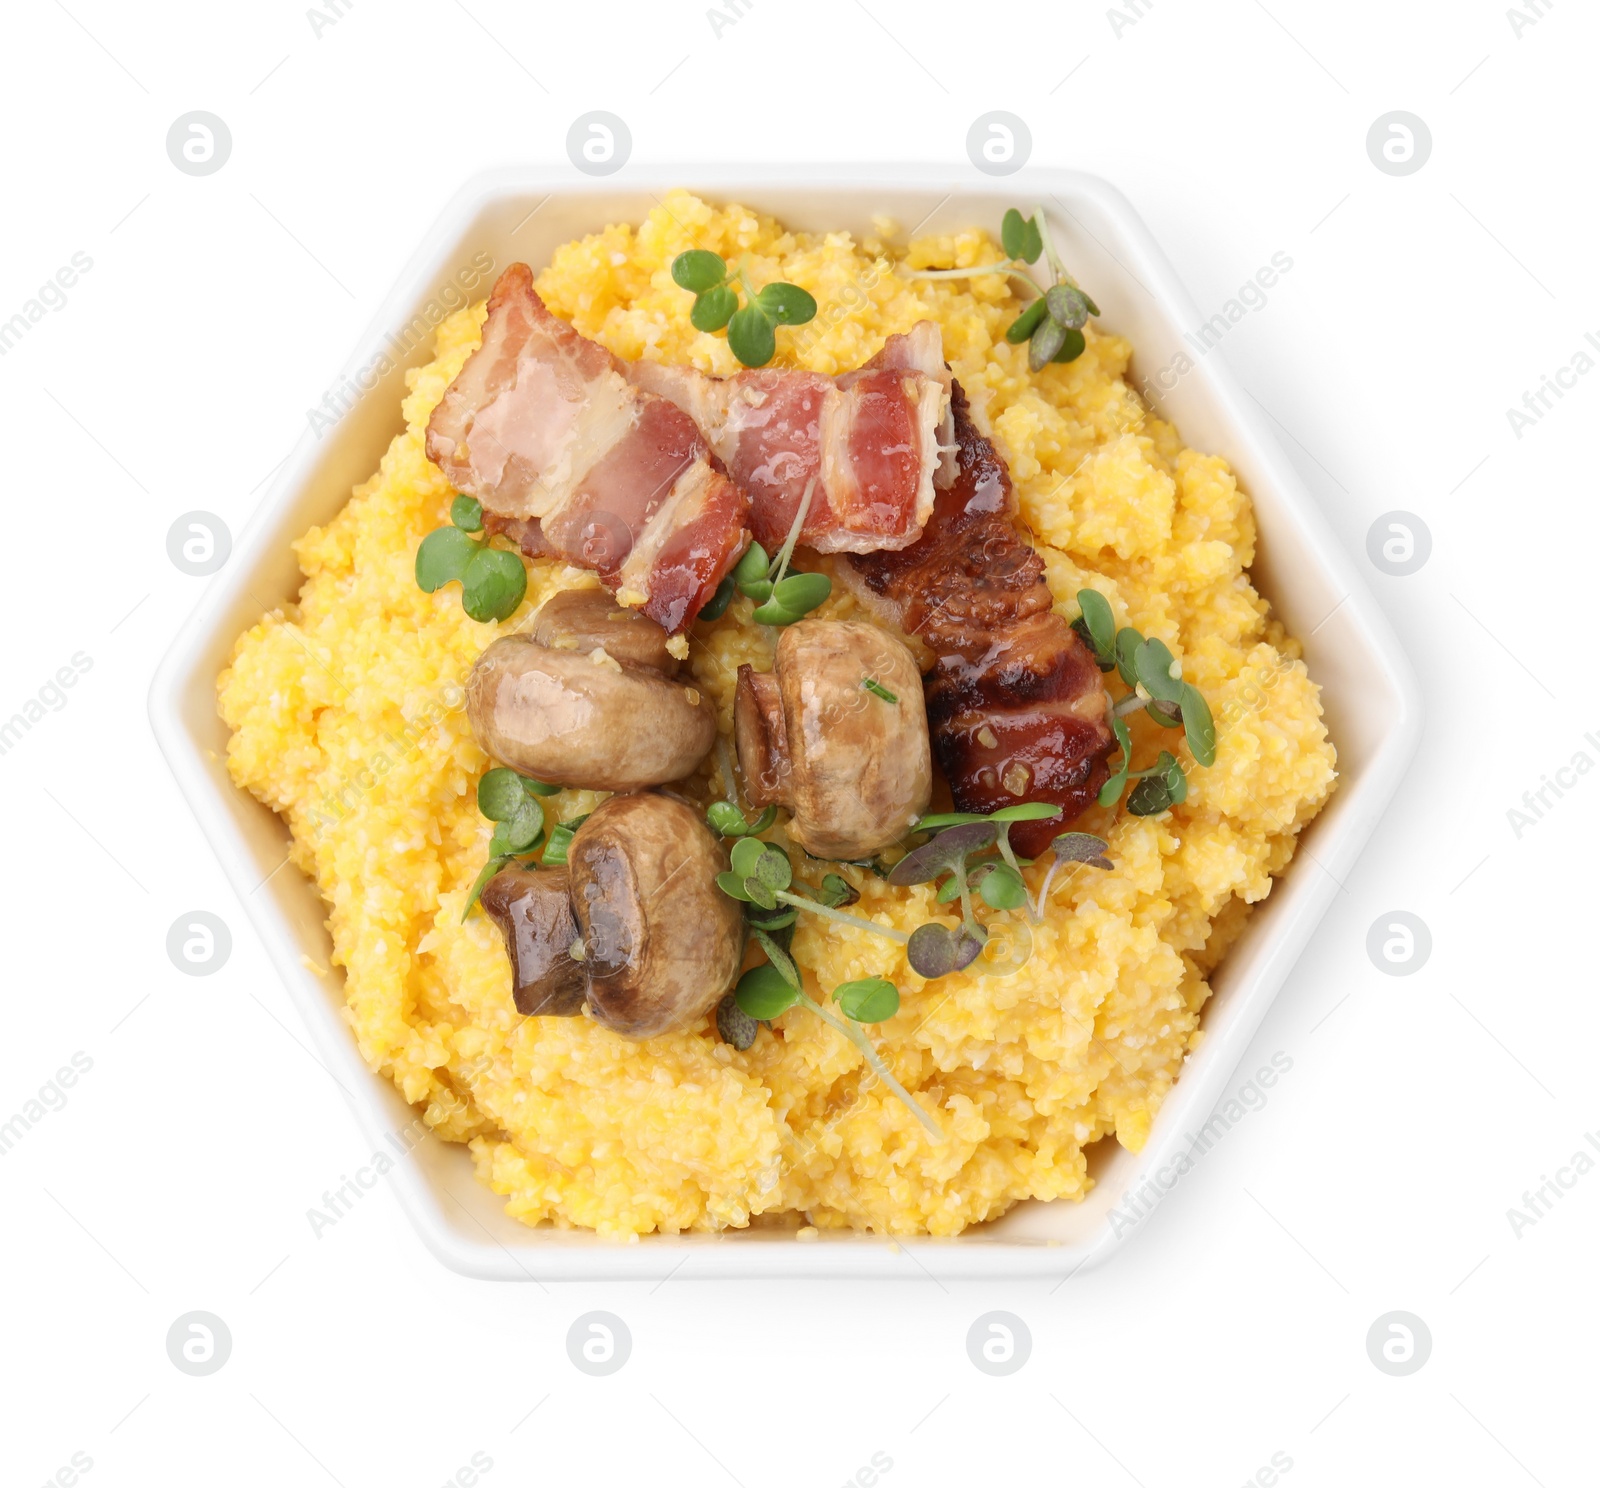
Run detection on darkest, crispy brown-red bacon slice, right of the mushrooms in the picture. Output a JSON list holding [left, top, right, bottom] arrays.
[[848, 382, 1115, 858]]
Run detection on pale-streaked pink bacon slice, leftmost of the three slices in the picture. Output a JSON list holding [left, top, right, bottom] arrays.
[[427, 264, 749, 634]]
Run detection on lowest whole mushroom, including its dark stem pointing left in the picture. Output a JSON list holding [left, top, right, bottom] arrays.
[[482, 792, 744, 1038]]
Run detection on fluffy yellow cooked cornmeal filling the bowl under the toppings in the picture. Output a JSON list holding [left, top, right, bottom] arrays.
[[218, 192, 1334, 1235]]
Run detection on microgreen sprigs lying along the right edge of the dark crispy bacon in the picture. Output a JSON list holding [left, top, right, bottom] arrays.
[[1072, 589, 1216, 816]]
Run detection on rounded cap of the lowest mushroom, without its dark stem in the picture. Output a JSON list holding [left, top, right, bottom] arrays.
[[566, 792, 744, 1038]]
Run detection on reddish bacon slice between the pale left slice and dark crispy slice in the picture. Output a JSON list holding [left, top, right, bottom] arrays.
[[627, 320, 950, 554]]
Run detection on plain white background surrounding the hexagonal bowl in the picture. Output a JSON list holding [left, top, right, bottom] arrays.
[[0, 0, 1600, 1488]]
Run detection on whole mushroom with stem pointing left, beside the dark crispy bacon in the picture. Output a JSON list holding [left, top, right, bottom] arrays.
[[733, 621, 933, 858]]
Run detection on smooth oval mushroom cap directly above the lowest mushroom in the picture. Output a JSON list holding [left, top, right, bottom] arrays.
[[467, 635, 717, 790]]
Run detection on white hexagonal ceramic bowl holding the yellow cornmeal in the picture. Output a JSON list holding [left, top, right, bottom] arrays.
[[150, 166, 1422, 1280]]
